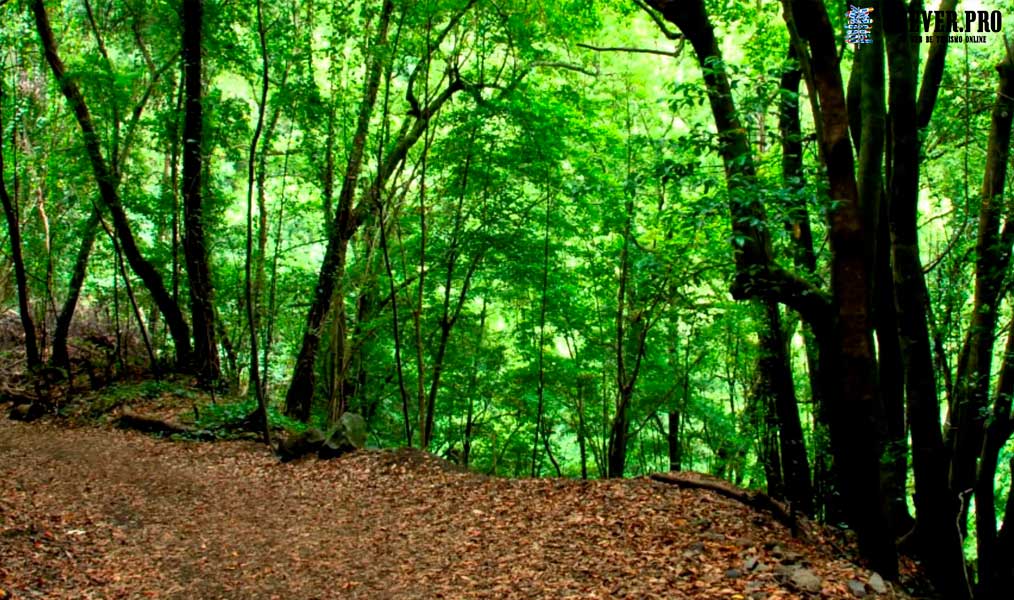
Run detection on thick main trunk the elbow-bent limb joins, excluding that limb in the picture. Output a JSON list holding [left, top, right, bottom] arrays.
[[785, 0, 897, 578]]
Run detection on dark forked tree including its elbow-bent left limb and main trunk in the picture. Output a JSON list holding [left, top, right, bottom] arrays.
[[649, 0, 897, 577]]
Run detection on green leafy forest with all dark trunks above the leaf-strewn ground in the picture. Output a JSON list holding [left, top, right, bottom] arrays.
[[0, 0, 1014, 600]]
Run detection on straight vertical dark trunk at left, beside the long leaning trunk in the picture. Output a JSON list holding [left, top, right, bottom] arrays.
[[180, 0, 221, 386]]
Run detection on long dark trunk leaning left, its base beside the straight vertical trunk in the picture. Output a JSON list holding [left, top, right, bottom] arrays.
[[31, 0, 191, 367]]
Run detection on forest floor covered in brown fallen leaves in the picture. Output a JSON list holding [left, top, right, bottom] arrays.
[[0, 403, 928, 600]]
